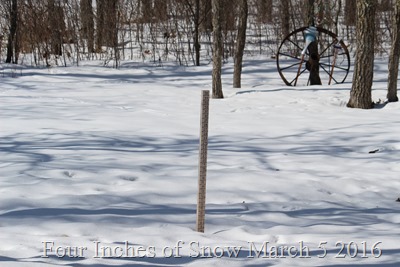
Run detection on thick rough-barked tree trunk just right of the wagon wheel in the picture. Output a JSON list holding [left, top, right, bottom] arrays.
[[347, 0, 376, 109]]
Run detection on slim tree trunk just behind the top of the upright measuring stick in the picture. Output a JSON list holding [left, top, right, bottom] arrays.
[[212, 0, 224, 98]]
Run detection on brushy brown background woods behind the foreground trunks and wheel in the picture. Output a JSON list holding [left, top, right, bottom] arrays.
[[0, 0, 394, 66]]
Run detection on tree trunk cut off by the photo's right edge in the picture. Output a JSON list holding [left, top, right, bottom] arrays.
[[387, 0, 400, 102]]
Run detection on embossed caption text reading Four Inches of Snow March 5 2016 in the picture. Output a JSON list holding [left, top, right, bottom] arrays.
[[41, 240, 382, 259]]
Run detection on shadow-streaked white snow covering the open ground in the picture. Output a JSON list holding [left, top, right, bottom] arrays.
[[0, 58, 400, 267]]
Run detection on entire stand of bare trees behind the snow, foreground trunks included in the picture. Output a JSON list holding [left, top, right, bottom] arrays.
[[0, 0, 400, 108]]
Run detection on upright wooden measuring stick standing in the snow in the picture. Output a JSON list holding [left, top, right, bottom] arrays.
[[196, 90, 210, 233]]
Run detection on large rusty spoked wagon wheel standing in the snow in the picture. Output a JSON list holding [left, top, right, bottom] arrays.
[[276, 27, 350, 86]]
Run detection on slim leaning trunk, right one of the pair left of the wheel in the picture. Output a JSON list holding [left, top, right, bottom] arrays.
[[233, 0, 249, 88]]
